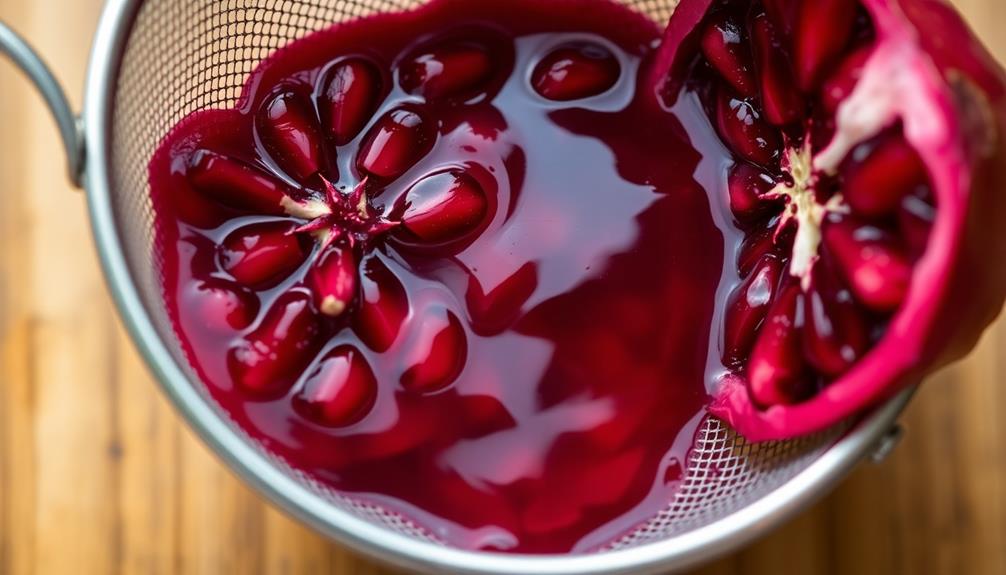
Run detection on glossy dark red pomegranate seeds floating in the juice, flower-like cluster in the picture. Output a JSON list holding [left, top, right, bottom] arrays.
[[185, 40, 620, 427]]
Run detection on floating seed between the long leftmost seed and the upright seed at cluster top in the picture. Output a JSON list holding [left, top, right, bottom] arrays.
[[259, 91, 322, 182]]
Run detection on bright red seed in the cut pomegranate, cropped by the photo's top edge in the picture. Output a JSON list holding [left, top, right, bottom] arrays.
[[794, 0, 858, 91]]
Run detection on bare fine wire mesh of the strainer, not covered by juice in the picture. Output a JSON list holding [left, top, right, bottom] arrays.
[[111, 0, 841, 551]]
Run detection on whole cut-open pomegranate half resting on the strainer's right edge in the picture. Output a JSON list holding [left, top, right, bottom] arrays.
[[650, 0, 1006, 440]]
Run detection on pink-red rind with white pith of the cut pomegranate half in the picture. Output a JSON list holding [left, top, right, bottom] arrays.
[[650, 0, 1006, 441]]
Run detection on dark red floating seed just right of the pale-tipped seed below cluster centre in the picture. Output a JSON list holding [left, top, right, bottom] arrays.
[[353, 256, 409, 352]]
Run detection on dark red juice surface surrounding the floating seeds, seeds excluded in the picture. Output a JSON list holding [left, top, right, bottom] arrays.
[[145, 0, 735, 553]]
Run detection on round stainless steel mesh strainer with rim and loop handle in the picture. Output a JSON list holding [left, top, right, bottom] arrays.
[[0, 0, 909, 575]]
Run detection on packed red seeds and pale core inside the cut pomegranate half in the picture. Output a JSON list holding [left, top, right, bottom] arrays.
[[692, 0, 937, 407]]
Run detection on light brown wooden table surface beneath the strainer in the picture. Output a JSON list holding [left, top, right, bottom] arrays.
[[0, 0, 1006, 575]]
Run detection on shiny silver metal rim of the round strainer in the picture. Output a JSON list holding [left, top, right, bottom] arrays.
[[82, 0, 912, 575]]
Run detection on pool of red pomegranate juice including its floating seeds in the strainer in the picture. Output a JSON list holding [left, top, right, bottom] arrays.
[[151, 0, 738, 553]]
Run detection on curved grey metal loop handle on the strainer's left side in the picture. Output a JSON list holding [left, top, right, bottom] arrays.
[[0, 22, 83, 187]]
